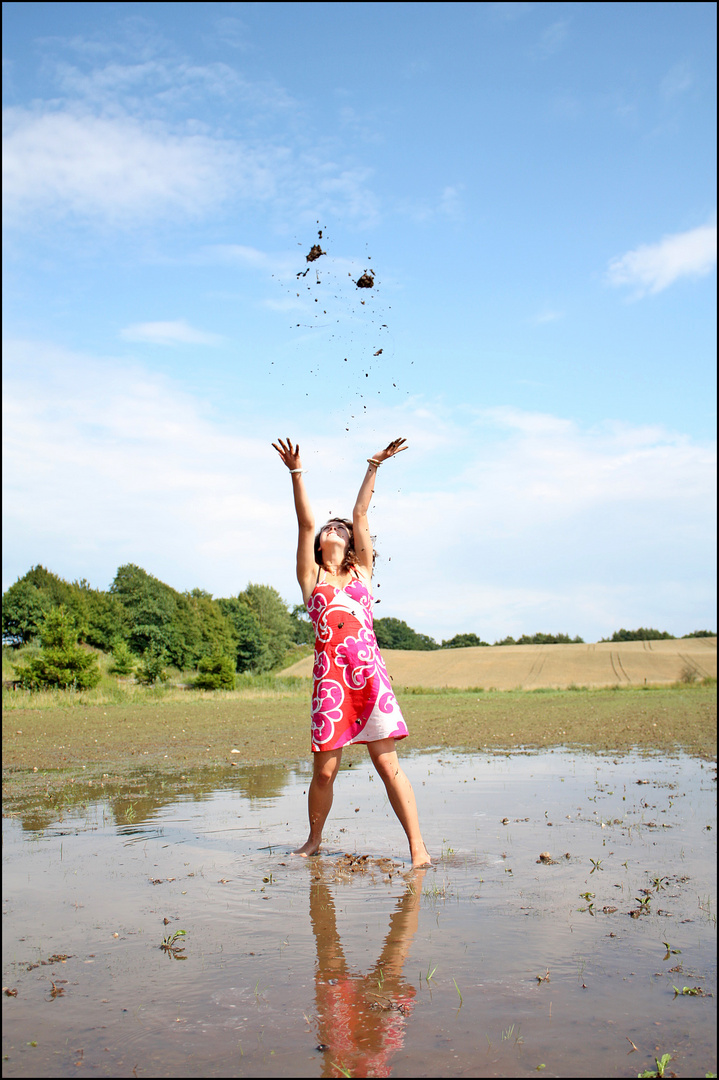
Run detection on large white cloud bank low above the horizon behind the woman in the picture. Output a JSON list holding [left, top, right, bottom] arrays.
[[3, 342, 716, 640]]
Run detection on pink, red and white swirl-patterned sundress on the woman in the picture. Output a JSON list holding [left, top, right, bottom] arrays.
[[307, 570, 409, 753]]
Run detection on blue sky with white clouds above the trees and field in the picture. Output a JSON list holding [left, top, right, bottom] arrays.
[[3, 3, 716, 642]]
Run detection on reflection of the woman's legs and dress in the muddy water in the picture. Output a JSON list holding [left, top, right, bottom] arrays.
[[310, 866, 424, 1077]]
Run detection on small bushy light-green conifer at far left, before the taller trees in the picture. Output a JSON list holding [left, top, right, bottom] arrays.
[[16, 605, 100, 690]]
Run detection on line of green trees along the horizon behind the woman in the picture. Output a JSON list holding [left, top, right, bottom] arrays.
[[2, 563, 714, 689]]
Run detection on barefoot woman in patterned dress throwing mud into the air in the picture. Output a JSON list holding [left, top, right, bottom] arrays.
[[272, 438, 430, 866]]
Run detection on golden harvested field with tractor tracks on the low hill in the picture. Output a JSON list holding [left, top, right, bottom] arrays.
[[284, 637, 717, 690]]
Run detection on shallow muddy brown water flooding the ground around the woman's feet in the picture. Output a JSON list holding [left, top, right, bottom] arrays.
[[2, 751, 716, 1077]]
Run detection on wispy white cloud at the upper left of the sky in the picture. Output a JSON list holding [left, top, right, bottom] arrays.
[[3, 42, 380, 227]]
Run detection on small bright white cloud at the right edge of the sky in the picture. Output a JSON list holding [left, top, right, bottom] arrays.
[[608, 221, 717, 296]]
